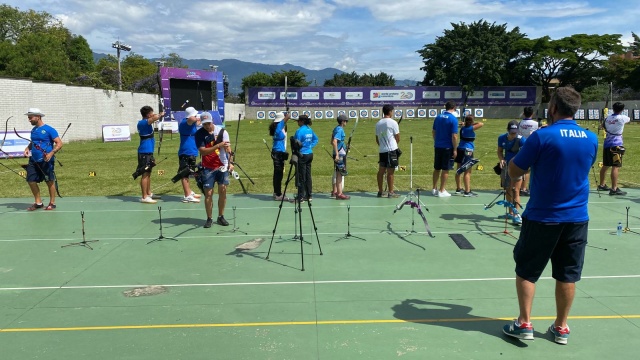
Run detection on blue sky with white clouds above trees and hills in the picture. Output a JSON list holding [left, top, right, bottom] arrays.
[[4, 0, 640, 81]]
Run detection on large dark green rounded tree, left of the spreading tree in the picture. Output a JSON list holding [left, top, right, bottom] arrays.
[[417, 20, 525, 95]]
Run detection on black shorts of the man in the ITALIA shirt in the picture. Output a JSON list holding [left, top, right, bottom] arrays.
[[513, 218, 589, 283]]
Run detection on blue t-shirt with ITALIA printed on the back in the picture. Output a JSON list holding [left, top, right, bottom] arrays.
[[513, 120, 598, 223]]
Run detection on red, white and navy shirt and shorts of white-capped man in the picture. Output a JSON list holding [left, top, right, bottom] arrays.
[[195, 125, 229, 189]]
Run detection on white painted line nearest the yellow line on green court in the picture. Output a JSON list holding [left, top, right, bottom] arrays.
[[0, 274, 640, 292]]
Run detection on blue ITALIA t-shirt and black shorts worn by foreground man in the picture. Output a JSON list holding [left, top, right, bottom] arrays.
[[513, 119, 598, 283]]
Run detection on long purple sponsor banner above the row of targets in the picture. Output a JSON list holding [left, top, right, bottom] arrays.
[[248, 86, 536, 108]]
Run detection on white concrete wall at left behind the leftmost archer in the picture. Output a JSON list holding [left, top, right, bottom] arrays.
[[0, 78, 156, 142]]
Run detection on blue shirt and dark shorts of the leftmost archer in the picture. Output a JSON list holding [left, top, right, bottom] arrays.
[[27, 124, 58, 183]]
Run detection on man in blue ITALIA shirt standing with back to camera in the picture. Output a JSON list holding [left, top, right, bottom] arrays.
[[503, 87, 598, 344]]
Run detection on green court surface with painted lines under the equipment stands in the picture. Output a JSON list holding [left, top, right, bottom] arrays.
[[0, 189, 640, 359]]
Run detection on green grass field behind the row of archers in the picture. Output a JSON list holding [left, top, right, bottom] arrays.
[[0, 119, 640, 197]]
